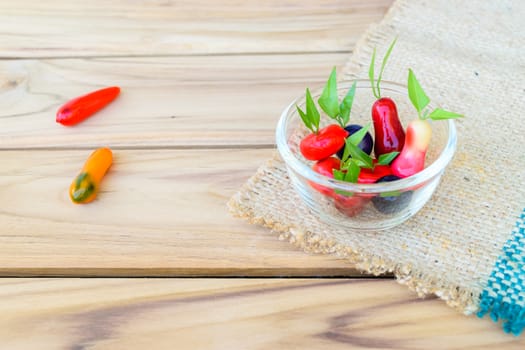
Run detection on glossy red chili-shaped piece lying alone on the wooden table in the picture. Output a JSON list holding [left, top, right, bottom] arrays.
[[56, 86, 120, 126]]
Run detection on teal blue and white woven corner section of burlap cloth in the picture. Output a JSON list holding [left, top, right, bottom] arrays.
[[478, 209, 525, 335]]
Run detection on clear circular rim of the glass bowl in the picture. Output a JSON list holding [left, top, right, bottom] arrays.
[[275, 79, 457, 193]]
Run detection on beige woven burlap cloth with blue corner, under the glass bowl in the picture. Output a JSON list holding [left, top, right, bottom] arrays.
[[229, 0, 525, 334]]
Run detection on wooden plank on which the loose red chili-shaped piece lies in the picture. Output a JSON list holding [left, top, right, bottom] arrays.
[[0, 54, 348, 149]]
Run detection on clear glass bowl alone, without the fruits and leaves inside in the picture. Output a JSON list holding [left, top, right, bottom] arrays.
[[276, 80, 457, 231]]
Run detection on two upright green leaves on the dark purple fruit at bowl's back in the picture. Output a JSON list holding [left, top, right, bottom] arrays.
[[318, 67, 356, 128]]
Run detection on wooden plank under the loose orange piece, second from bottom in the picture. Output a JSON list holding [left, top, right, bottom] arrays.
[[0, 149, 364, 276]]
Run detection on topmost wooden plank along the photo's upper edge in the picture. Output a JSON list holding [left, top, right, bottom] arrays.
[[0, 0, 392, 58]]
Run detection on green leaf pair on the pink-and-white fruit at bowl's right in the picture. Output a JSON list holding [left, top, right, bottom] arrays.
[[408, 69, 464, 120]]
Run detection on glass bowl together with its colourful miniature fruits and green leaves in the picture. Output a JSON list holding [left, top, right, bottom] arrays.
[[276, 44, 462, 231]]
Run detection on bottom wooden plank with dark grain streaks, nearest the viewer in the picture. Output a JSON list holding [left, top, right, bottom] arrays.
[[0, 279, 525, 350]]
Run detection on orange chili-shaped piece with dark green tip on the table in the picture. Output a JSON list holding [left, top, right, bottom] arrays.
[[69, 147, 113, 204]]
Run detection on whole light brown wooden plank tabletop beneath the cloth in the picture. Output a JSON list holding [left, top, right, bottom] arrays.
[[0, 0, 524, 349]]
